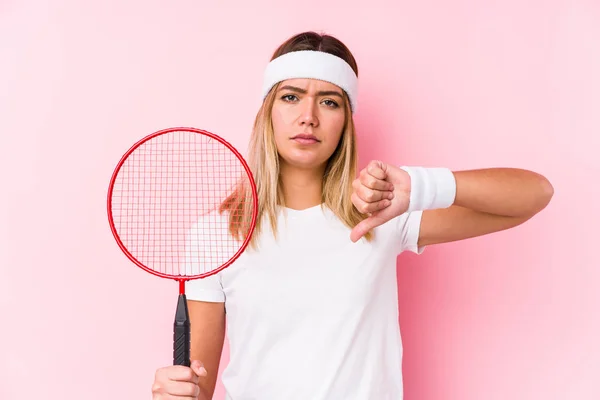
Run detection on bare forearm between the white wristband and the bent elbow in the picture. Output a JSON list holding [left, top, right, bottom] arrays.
[[453, 168, 554, 217]]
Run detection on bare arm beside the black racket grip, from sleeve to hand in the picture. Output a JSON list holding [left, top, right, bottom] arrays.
[[188, 301, 225, 399]]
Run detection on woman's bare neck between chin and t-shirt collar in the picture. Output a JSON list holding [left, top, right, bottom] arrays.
[[280, 163, 325, 210]]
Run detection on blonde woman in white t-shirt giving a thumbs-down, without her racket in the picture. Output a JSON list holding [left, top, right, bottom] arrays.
[[152, 32, 553, 400]]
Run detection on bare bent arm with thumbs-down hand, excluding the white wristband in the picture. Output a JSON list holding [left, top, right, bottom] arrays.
[[350, 161, 554, 247]]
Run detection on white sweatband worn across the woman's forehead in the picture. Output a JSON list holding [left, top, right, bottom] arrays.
[[262, 50, 358, 112]]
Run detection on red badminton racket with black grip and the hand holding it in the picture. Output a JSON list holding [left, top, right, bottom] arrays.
[[107, 128, 258, 398]]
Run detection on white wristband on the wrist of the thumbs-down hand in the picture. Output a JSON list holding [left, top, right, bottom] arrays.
[[400, 166, 456, 212]]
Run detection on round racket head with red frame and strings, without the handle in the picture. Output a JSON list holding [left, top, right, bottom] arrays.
[[107, 127, 258, 282]]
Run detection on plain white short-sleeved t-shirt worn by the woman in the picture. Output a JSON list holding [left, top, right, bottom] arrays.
[[186, 206, 424, 400]]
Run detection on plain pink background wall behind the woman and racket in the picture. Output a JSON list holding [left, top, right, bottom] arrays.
[[0, 0, 600, 400]]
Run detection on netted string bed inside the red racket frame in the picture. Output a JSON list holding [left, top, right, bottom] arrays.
[[112, 131, 250, 276]]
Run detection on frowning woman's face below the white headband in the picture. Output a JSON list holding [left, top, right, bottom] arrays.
[[272, 79, 345, 169]]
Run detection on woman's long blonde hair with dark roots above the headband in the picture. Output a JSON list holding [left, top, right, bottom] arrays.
[[219, 32, 373, 249]]
